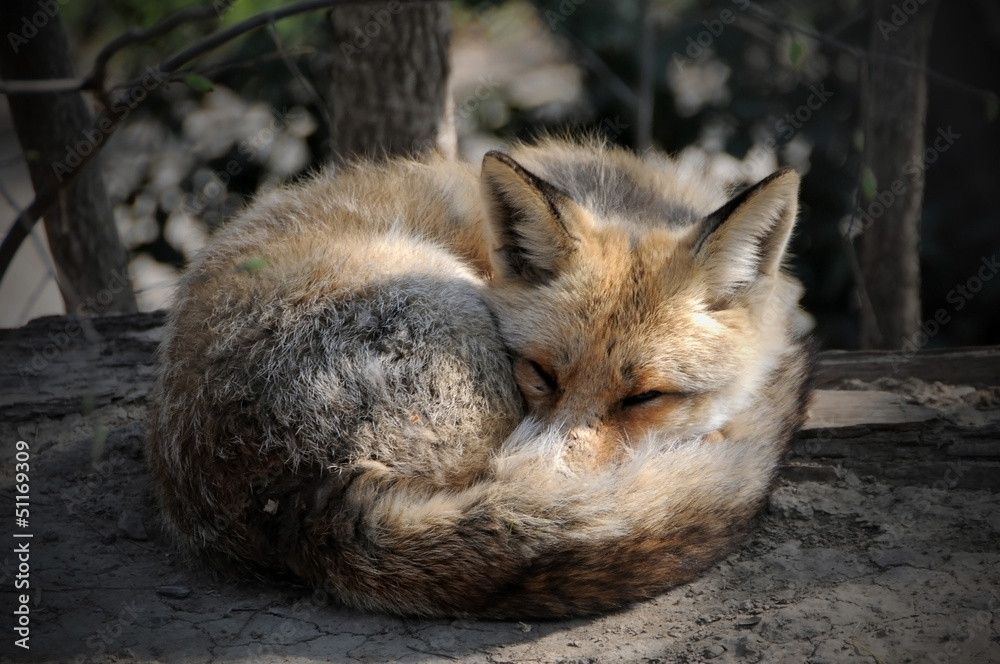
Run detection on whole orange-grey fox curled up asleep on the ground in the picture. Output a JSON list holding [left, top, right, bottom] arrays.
[[147, 139, 810, 619]]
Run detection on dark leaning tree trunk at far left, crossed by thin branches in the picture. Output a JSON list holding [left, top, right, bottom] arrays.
[[0, 0, 136, 315]]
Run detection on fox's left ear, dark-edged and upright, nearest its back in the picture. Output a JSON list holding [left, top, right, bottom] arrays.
[[480, 150, 578, 284]]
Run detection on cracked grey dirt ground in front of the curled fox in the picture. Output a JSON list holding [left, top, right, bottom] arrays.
[[0, 399, 1000, 664]]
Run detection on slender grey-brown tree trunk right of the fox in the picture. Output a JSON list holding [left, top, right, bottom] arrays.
[[860, 0, 936, 349]]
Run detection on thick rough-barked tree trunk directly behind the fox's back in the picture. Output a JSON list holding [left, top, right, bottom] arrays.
[[328, 1, 456, 160]]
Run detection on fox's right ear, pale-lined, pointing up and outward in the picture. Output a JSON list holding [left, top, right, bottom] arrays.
[[694, 168, 799, 295]]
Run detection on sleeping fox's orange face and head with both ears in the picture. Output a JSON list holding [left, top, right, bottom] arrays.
[[481, 145, 800, 466]]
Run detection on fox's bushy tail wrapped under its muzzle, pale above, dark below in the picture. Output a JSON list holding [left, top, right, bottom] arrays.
[[292, 402, 800, 619]]
